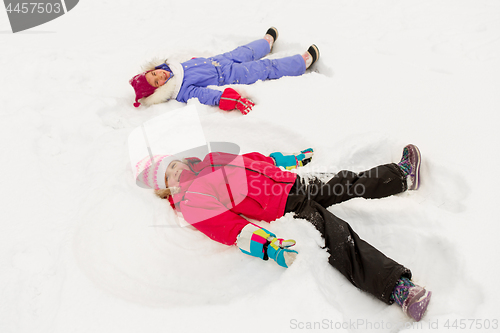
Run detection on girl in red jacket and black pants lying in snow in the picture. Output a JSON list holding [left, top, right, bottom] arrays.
[[137, 145, 431, 321]]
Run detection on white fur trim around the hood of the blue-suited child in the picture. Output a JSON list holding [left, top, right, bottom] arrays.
[[139, 58, 184, 106]]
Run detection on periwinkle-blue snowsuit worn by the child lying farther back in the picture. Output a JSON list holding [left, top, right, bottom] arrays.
[[176, 39, 306, 105]]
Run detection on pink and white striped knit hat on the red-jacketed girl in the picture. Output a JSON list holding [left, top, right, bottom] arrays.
[[135, 155, 174, 190]]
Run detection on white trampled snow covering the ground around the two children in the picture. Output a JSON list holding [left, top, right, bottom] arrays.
[[0, 0, 500, 333]]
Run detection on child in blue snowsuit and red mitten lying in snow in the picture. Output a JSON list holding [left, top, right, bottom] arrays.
[[130, 28, 319, 114]]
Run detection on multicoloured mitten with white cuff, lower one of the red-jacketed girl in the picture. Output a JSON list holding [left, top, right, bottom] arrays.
[[236, 223, 298, 267]]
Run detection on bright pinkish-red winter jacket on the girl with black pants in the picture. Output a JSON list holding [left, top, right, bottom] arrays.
[[171, 153, 297, 245]]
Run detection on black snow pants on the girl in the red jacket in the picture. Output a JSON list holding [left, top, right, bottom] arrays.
[[285, 163, 411, 304]]
